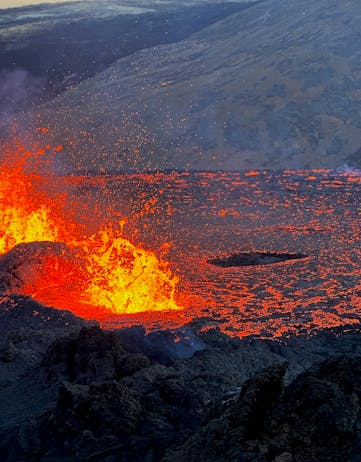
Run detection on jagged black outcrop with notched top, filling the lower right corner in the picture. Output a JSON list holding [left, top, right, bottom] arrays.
[[163, 356, 361, 462]]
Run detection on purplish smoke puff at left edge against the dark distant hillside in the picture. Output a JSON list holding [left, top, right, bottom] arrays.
[[0, 69, 45, 123]]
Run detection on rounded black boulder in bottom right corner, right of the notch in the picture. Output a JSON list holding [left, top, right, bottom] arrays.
[[267, 356, 361, 462]]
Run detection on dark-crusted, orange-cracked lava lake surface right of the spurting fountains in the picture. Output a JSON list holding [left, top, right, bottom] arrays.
[[93, 170, 361, 338]]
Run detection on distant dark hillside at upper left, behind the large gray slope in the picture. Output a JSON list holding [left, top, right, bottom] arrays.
[[0, 0, 253, 116]]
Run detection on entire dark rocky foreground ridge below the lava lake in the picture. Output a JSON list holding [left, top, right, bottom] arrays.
[[0, 296, 361, 462]]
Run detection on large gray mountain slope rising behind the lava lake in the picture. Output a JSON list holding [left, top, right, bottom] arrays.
[[19, 0, 361, 169]]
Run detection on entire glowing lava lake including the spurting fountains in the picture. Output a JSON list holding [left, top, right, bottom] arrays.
[[0, 135, 361, 337]]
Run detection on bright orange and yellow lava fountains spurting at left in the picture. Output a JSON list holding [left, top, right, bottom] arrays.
[[0, 134, 181, 317]]
